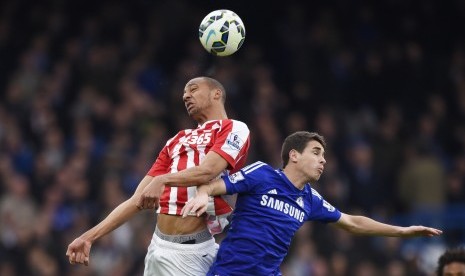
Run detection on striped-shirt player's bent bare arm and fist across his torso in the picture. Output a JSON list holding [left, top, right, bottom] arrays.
[[137, 151, 228, 209]]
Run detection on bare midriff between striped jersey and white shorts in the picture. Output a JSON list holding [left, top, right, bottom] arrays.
[[157, 214, 207, 235]]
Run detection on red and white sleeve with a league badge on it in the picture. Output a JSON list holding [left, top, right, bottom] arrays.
[[210, 120, 250, 172]]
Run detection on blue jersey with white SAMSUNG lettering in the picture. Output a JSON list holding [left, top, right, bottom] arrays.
[[208, 162, 341, 276]]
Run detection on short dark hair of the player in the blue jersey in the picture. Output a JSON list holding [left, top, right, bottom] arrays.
[[281, 131, 326, 168]]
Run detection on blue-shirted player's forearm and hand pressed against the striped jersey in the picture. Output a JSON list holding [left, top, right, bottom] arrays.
[[181, 179, 226, 218]]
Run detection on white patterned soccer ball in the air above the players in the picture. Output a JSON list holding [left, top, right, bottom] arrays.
[[199, 10, 245, 56]]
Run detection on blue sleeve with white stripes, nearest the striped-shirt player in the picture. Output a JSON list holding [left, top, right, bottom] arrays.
[[223, 162, 266, 194]]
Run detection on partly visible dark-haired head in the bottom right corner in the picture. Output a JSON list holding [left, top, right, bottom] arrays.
[[436, 247, 465, 276]]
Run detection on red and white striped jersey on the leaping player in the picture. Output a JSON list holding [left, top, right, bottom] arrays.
[[147, 119, 250, 216]]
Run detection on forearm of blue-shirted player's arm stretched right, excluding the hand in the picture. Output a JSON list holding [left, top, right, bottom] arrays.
[[339, 216, 404, 237]]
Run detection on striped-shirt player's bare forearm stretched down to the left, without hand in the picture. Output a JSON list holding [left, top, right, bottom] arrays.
[[81, 199, 139, 242]]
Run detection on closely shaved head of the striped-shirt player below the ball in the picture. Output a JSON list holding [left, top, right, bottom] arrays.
[[183, 77, 226, 121]]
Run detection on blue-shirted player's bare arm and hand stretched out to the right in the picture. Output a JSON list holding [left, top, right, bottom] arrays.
[[335, 213, 442, 237]]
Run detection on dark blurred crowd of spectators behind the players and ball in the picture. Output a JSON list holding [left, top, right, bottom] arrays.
[[0, 0, 465, 276]]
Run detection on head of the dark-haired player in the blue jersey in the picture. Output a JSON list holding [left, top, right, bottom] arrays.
[[281, 131, 326, 181]]
